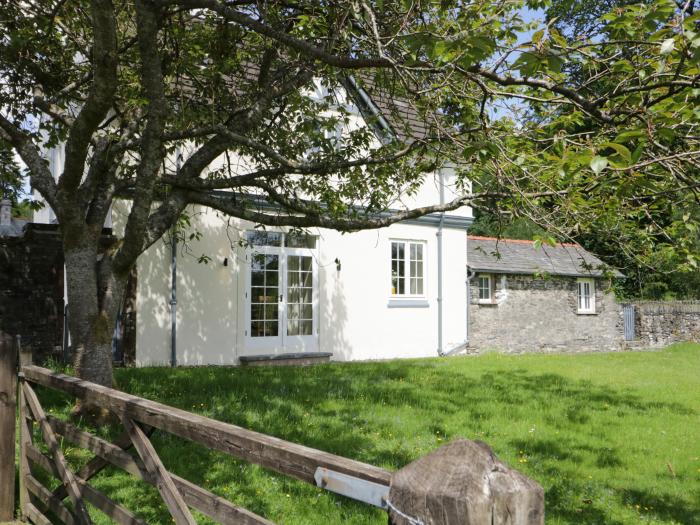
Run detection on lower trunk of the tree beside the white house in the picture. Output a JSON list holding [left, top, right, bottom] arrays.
[[64, 235, 126, 387]]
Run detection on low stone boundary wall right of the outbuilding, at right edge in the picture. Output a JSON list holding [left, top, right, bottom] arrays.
[[628, 301, 700, 347]]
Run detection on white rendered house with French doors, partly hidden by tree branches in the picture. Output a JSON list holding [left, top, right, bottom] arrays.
[[36, 78, 472, 366]]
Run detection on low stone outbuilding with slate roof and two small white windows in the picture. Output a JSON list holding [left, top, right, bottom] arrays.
[[467, 235, 623, 353]]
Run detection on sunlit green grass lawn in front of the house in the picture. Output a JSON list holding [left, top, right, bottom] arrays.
[[34, 344, 700, 525]]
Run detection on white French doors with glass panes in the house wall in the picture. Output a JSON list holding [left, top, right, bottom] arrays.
[[245, 234, 318, 355]]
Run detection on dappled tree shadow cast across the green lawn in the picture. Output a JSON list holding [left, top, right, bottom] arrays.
[[34, 361, 698, 525]]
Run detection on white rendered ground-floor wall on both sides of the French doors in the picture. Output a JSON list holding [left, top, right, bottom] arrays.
[[130, 203, 467, 366]]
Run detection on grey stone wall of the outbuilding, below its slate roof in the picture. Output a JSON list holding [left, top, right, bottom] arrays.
[[469, 274, 623, 353]]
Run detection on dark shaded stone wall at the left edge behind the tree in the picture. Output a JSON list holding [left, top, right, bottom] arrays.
[[0, 224, 63, 362]]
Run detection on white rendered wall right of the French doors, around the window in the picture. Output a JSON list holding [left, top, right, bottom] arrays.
[[319, 224, 467, 361]]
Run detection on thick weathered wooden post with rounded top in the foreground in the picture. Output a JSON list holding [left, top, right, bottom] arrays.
[[387, 439, 544, 525]]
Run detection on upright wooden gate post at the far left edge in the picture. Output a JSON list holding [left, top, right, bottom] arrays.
[[0, 331, 17, 522]]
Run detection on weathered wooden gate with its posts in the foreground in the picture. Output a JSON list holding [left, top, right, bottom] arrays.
[[0, 333, 544, 525]]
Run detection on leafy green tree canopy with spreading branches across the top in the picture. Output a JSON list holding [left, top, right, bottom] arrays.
[[0, 0, 700, 383]]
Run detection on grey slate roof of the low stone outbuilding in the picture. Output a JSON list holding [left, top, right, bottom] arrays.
[[467, 235, 624, 277]]
